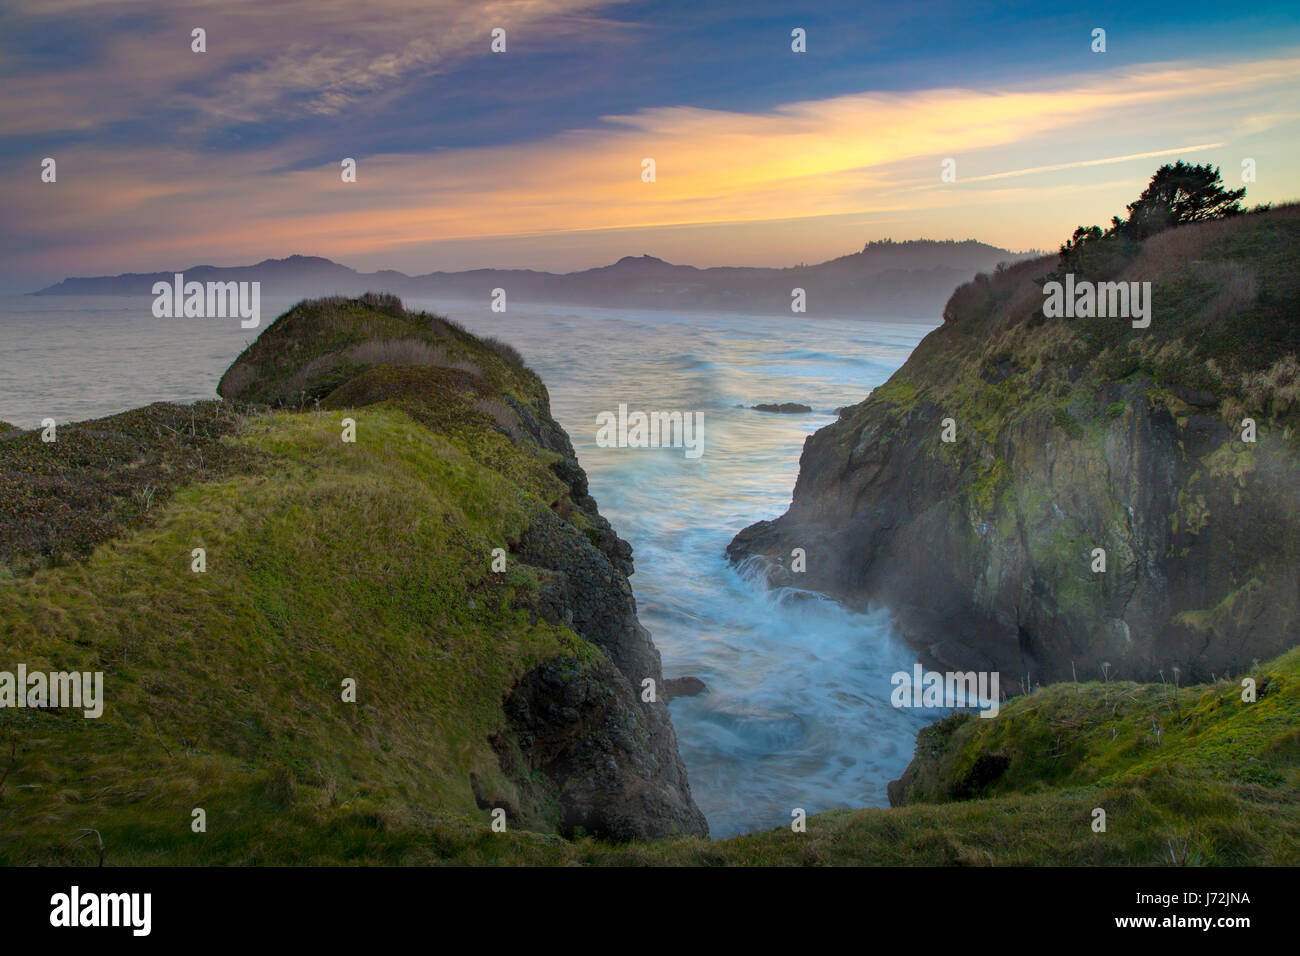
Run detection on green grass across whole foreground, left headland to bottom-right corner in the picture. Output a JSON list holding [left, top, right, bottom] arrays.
[[0, 295, 1300, 865]]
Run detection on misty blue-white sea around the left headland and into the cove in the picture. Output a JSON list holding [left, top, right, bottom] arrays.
[[0, 294, 940, 836]]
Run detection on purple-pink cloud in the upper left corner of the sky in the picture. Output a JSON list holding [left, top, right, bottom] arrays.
[[0, 0, 624, 137]]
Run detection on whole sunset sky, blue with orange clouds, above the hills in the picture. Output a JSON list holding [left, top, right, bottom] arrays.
[[0, 0, 1300, 293]]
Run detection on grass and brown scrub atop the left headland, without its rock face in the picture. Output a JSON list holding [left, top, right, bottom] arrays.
[[0, 302, 599, 864]]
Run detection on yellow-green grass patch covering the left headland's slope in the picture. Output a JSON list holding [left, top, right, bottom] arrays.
[[0, 407, 599, 862]]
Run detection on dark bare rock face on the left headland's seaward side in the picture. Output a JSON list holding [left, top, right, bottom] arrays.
[[506, 395, 709, 840]]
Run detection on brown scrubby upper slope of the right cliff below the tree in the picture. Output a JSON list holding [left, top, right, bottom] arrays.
[[850, 204, 1300, 478]]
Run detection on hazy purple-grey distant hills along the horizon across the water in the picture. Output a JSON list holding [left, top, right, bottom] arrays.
[[33, 239, 1036, 320]]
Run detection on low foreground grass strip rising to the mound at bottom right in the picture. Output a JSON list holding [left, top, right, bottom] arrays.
[[421, 649, 1300, 865]]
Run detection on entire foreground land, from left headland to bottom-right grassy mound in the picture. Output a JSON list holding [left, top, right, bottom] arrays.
[[0, 293, 1300, 866]]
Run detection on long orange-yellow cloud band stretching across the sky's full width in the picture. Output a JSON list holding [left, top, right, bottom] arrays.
[[7, 51, 1300, 280]]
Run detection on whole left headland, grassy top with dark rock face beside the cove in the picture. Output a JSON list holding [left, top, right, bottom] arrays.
[[0, 297, 707, 864]]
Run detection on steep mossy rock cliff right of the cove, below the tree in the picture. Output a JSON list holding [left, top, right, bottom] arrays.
[[728, 206, 1300, 691]]
